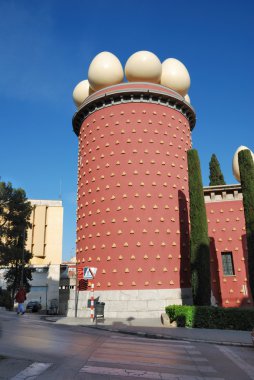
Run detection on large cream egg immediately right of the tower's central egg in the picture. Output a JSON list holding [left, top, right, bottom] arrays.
[[161, 58, 190, 96]]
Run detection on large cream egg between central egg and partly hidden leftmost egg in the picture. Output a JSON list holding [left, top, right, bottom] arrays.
[[88, 51, 124, 91]]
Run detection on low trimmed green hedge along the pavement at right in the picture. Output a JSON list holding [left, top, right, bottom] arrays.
[[166, 305, 254, 331]]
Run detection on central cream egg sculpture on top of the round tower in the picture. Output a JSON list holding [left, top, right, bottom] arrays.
[[125, 50, 161, 83]]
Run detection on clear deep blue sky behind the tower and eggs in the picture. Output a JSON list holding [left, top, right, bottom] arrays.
[[0, 0, 254, 260]]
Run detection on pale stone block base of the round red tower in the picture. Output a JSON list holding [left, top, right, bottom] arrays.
[[67, 288, 192, 319]]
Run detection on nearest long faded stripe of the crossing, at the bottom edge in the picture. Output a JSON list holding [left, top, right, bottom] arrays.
[[79, 366, 224, 380]]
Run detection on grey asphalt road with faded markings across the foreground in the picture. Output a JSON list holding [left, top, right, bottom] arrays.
[[0, 313, 254, 380]]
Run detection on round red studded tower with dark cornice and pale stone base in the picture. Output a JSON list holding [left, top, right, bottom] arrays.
[[73, 83, 195, 316]]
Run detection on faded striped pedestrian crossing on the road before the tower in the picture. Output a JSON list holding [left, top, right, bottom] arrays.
[[80, 334, 221, 380]]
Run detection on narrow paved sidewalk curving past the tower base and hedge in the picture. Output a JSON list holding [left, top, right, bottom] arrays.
[[44, 316, 253, 347]]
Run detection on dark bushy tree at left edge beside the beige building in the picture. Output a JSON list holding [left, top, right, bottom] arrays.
[[0, 182, 32, 300]]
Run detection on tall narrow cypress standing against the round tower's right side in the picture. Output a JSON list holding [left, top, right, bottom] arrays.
[[187, 149, 211, 306]]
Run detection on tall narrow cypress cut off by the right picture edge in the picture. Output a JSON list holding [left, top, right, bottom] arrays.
[[238, 149, 254, 299]]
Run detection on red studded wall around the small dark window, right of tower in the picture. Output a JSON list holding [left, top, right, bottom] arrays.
[[206, 200, 252, 307]]
